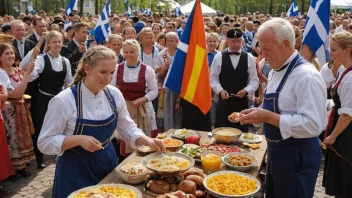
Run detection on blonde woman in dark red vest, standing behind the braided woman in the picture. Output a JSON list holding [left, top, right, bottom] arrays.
[[111, 40, 158, 162]]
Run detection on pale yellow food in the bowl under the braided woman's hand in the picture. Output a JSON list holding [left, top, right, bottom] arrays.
[[147, 156, 188, 171]]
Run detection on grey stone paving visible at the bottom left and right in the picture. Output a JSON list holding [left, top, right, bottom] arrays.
[[3, 156, 332, 198]]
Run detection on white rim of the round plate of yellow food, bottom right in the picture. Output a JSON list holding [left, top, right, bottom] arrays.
[[203, 170, 261, 198]]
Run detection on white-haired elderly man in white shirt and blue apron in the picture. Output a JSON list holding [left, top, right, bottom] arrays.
[[238, 18, 327, 198]]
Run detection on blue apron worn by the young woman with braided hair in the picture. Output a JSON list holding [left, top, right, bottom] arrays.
[[53, 82, 118, 198]]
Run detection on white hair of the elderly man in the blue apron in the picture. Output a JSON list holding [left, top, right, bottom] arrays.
[[256, 18, 296, 48]]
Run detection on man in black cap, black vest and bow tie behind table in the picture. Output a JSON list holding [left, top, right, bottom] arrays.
[[210, 28, 259, 132]]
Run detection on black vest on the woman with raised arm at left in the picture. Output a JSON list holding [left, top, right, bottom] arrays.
[[39, 54, 67, 95]]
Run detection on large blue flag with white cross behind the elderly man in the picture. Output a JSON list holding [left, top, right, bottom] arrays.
[[303, 0, 330, 66]]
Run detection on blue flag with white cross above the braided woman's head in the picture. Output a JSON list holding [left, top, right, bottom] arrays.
[[95, 0, 111, 44]]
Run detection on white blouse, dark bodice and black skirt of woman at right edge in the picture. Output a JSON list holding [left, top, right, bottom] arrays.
[[322, 66, 352, 197]]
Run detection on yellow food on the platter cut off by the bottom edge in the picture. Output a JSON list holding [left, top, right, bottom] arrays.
[[74, 186, 137, 198]]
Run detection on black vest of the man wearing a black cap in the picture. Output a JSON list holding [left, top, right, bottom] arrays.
[[219, 49, 248, 94]]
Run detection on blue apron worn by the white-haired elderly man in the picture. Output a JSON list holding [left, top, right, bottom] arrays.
[[263, 55, 322, 198]]
